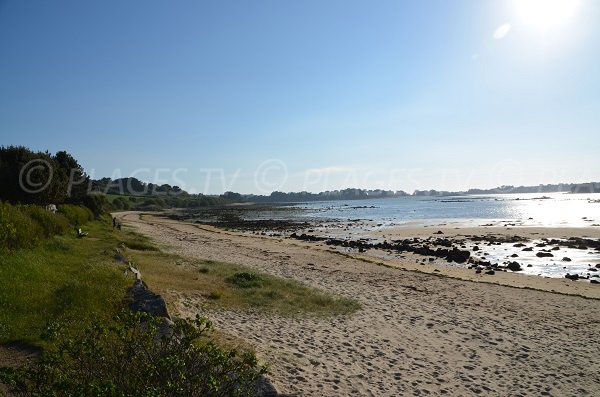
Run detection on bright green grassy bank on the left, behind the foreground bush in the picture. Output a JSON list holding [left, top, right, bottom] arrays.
[[0, 221, 131, 345]]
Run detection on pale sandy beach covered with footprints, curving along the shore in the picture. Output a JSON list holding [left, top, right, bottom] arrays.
[[118, 213, 600, 396]]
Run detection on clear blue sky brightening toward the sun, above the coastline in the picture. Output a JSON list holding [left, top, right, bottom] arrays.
[[0, 0, 600, 194]]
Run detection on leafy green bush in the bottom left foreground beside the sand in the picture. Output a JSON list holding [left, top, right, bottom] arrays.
[[0, 312, 266, 397]]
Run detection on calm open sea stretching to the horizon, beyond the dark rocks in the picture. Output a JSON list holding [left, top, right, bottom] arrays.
[[296, 193, 600, 227]]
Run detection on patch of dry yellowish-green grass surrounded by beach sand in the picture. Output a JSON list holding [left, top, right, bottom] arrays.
[[125, 250, 360, 316]]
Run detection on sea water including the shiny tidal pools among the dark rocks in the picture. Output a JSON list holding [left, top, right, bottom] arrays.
[[278, 193, 600, 282]]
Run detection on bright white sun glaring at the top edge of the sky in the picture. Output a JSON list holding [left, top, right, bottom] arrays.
[[514, 0, 580, 31]]
